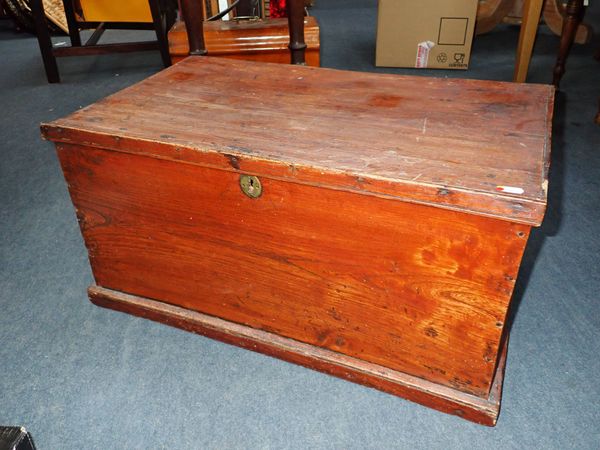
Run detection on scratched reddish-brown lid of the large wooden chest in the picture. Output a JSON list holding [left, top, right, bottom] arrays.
[[42, 57, 554, 225]]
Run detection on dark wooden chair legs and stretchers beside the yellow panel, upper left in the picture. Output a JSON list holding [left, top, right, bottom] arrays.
[[31, 0, 175, 83]]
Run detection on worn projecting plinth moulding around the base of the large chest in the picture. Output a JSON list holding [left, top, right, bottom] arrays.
[[88, 285, 508, 426]]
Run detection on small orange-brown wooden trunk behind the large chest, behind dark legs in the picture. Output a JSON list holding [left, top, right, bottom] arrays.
[[169, 16, 320, 67]]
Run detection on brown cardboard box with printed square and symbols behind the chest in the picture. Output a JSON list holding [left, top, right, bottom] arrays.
[[375, 0, 477, 69]]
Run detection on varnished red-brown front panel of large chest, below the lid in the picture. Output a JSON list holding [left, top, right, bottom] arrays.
[[54, 144, 529, 398]]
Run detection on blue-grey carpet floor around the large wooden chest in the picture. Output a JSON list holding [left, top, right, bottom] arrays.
[[0, 0, 600, 450]]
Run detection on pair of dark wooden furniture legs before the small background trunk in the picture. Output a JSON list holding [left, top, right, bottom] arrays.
[[181, 0, 306, 65]]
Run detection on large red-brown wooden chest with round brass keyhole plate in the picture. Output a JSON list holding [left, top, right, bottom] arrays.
[[42, 57, 553, 425]]
